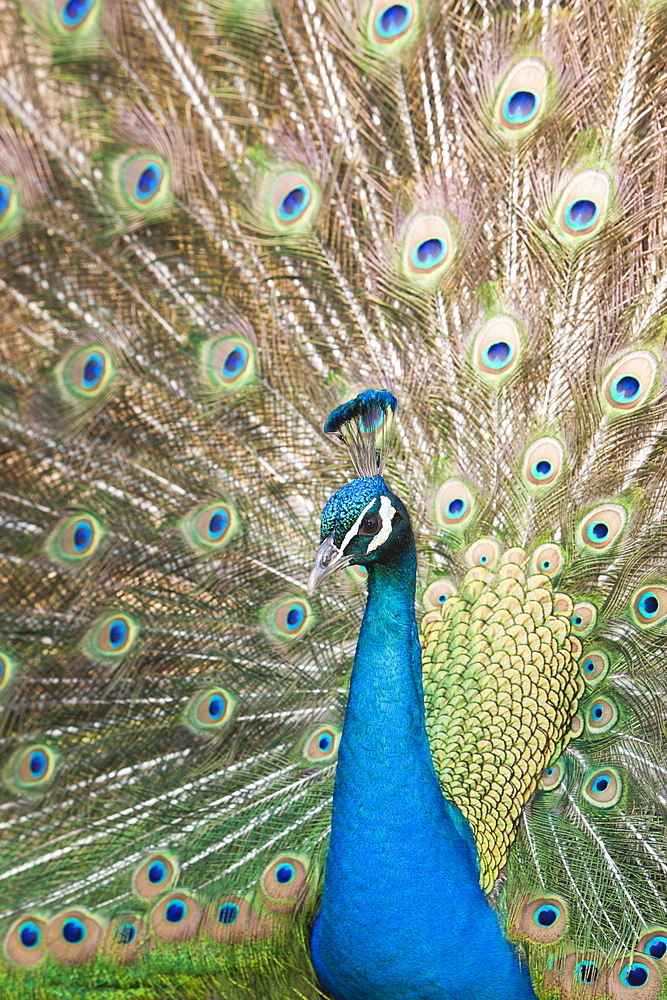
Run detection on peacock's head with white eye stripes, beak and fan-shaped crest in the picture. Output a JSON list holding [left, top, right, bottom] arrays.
[[308, 389, 412, 594]]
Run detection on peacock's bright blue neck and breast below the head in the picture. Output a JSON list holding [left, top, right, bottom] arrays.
[[312, 542, 534, 1000]]
